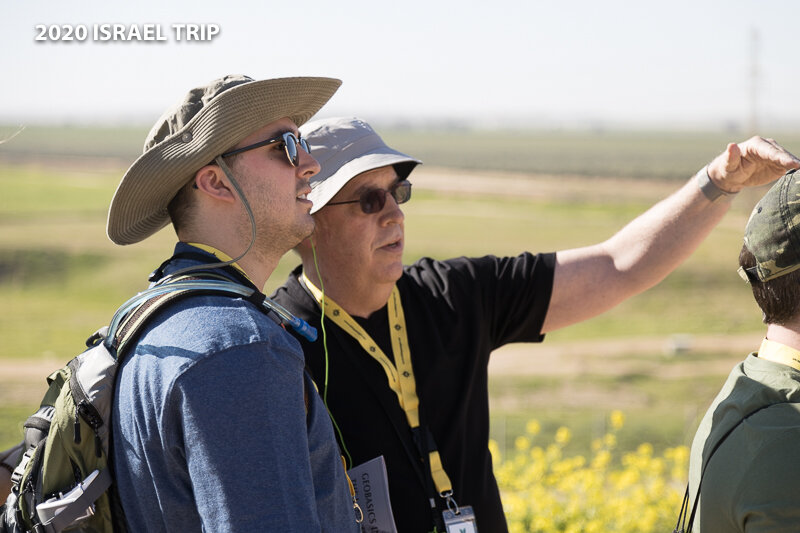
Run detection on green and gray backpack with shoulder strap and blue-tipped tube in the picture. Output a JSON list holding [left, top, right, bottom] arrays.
[[0, 277, 316, 533]]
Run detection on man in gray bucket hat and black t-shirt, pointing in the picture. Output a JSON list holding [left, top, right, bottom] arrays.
[[274, 118, 800, 533]]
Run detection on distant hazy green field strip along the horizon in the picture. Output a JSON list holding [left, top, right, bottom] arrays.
[[6, 122, 800, 180]]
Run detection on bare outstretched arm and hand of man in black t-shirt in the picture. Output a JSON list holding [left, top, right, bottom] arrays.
[[542, 137, 800, 332]]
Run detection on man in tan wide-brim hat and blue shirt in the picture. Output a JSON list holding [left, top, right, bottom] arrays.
[[108, 76, 358, 532]]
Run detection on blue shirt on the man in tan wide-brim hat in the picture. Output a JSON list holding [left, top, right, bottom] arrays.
[[113, 244, 358, 533]]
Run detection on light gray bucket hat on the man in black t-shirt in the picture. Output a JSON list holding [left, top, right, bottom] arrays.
[[300, 117, 422, 213]]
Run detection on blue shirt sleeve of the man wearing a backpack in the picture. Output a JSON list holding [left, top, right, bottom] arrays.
[[170, 342, 321, 531]]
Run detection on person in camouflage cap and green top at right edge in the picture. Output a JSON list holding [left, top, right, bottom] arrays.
[[687, 170, 800, 533]]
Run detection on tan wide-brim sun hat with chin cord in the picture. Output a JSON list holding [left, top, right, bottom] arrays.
[[107, 75, 342, 244]]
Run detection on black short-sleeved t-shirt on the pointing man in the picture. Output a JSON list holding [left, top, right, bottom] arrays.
[[273, 253, 555, 533]]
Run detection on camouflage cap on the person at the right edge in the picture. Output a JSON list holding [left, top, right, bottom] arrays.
[[739, 170, 800, 282]]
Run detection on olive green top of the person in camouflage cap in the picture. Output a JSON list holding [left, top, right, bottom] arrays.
[[689, 353, 800, 533]]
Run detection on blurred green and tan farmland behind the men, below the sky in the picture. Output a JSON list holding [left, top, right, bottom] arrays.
[[0, 122, 800, 460]]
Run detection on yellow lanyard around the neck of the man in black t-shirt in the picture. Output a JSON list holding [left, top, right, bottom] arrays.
[[302, 272, 453, 497]]
